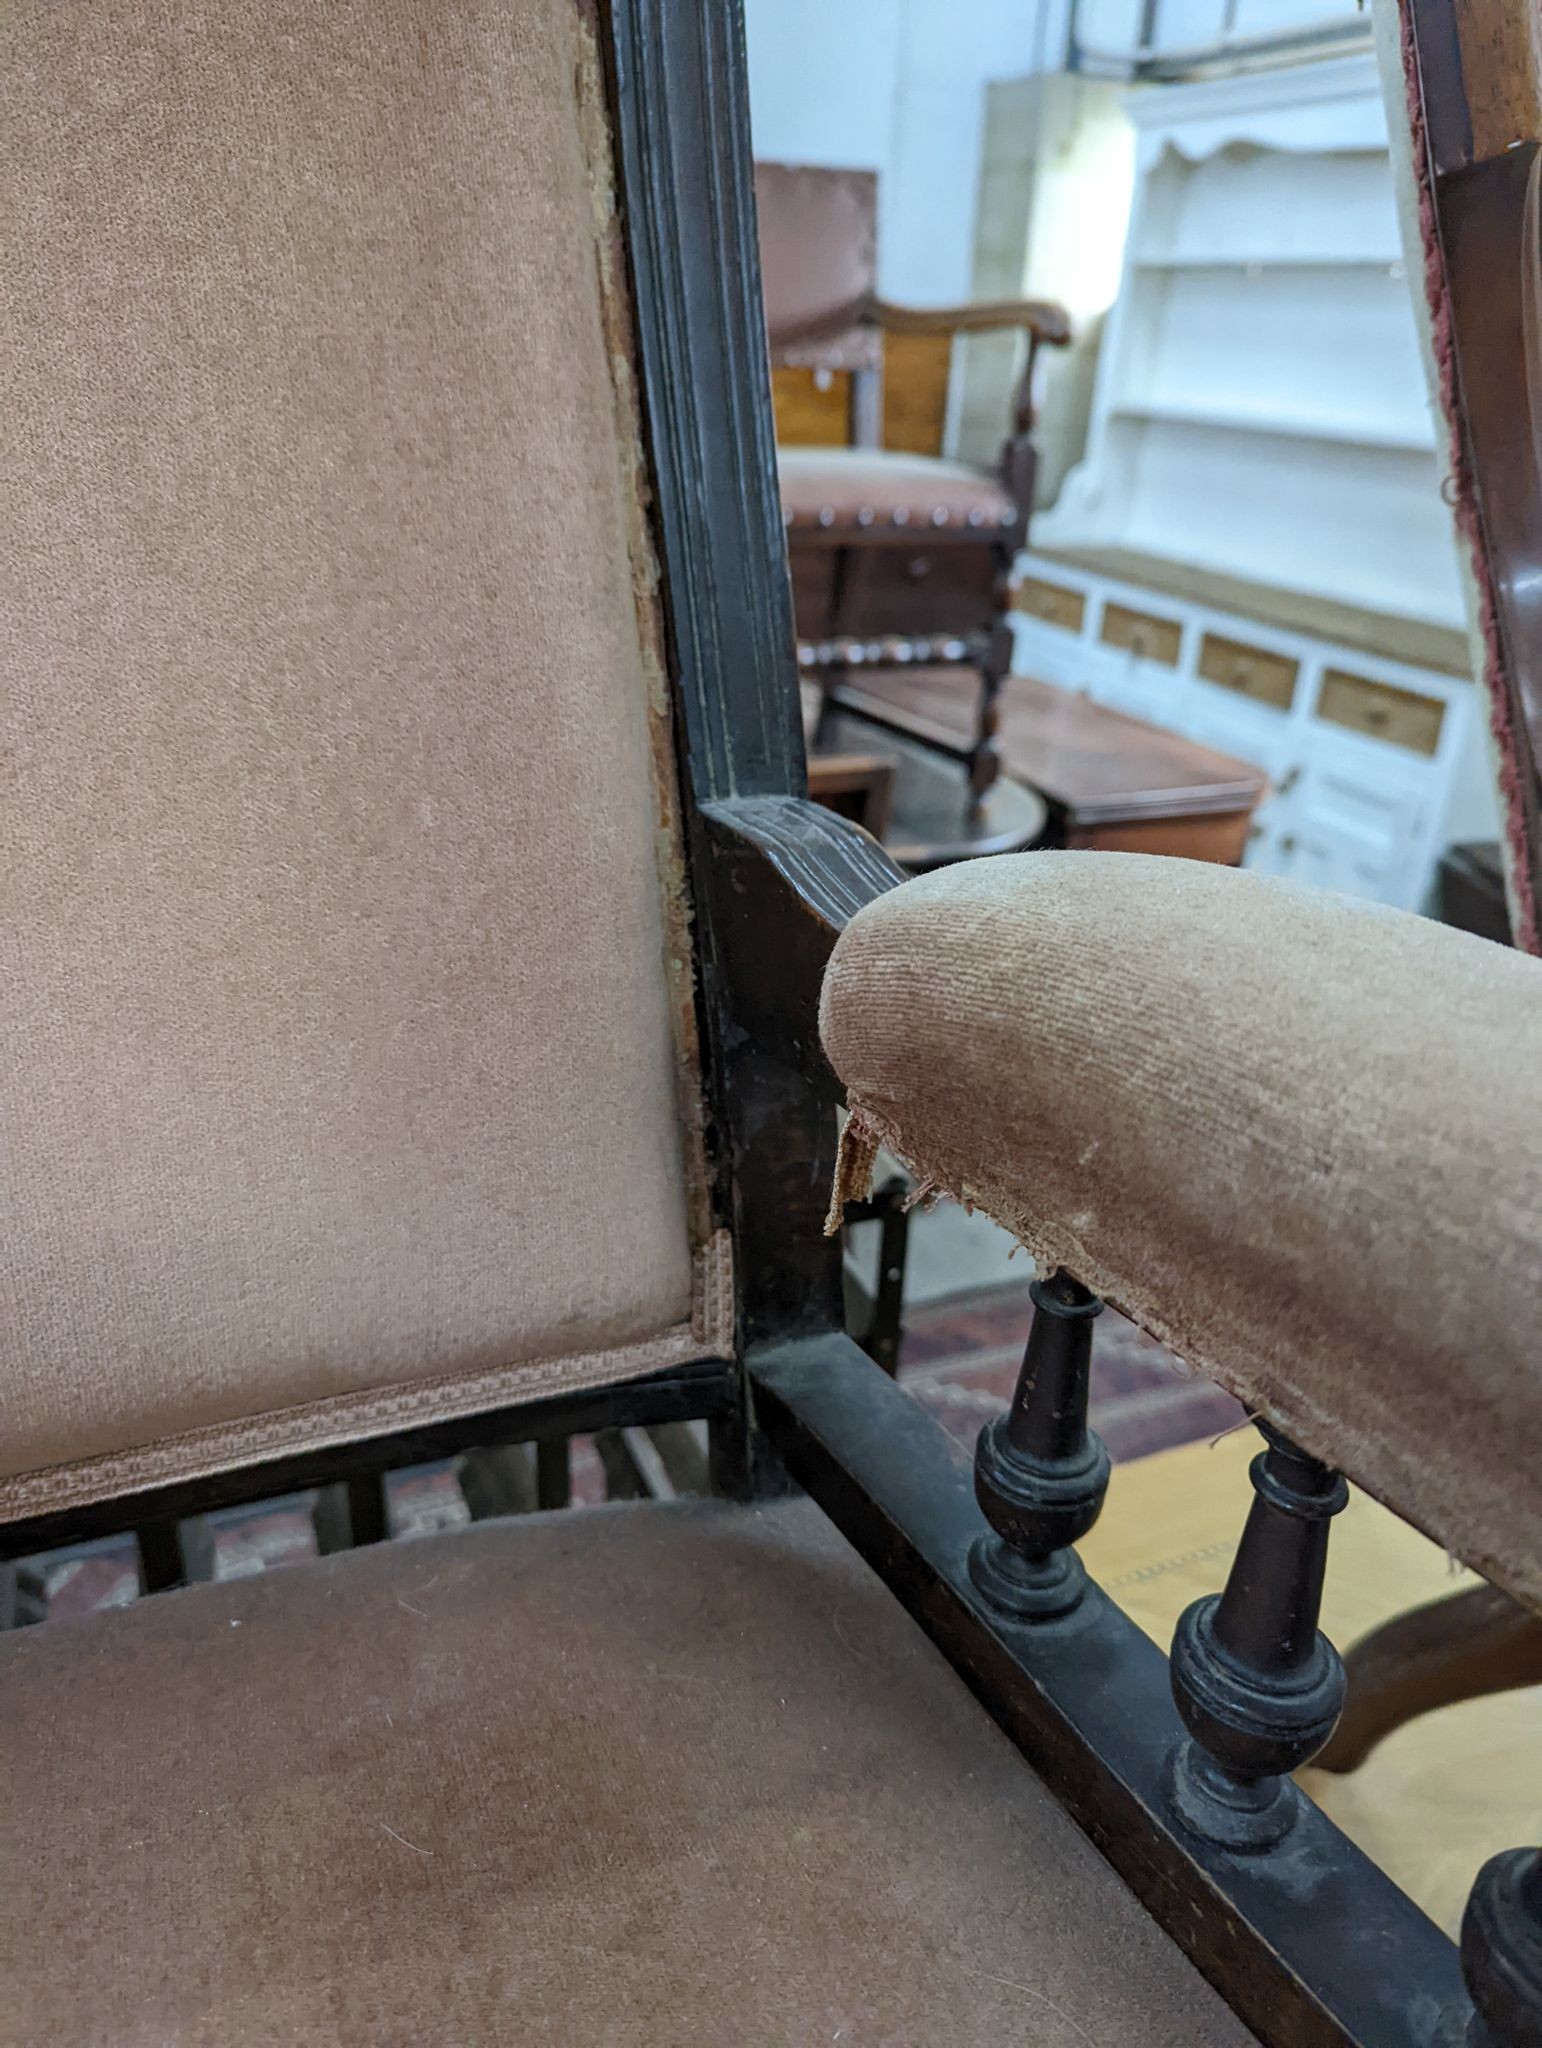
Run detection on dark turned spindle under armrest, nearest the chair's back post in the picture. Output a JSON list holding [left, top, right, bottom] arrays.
[[969, 1272, 1108, 1620]]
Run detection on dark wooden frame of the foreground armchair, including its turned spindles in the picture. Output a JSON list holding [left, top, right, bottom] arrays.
[[4, 0, 1542, 2048]]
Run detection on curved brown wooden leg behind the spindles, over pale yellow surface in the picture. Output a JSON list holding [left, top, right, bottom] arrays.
[[1315, 1585, 1542, 1772]]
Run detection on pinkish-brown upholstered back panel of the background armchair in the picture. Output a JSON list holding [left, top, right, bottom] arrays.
[[756, 164, 883, 371]]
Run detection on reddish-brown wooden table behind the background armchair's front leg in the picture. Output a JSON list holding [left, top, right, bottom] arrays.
[[846, 670, 1268, 866]]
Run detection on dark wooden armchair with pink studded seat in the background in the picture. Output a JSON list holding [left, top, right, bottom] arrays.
[[756, 164, 1071, 793]]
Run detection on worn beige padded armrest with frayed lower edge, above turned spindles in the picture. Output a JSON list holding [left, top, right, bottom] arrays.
[[823, 852, 1542, 1606]]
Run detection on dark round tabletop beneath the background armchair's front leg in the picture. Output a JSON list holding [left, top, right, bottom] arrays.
[[813, 711, 1048, 874]]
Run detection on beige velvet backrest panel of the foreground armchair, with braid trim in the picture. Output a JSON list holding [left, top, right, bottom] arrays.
[[0, 0, 702, 1513]]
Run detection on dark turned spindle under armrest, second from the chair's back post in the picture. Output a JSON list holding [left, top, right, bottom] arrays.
[[1169, 1421, 1350, 1849]]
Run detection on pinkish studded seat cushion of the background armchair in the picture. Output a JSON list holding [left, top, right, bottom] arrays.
[[776, 449, 1018, 535]]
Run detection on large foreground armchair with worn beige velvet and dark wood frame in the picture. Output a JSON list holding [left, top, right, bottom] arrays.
[[0, 0, 1542, 2048]]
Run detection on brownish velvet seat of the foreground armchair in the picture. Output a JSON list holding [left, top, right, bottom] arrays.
[[0, 1503, 1251, 2048]]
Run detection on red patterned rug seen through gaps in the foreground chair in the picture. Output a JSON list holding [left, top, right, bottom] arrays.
[[20, 1280, 1243, 1620]]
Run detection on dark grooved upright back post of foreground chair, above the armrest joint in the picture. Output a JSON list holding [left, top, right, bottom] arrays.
[[612, 0, 807, 801]]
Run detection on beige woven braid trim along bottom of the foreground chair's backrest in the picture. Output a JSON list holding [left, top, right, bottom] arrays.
[[0, 1231, 733, 1524]]
